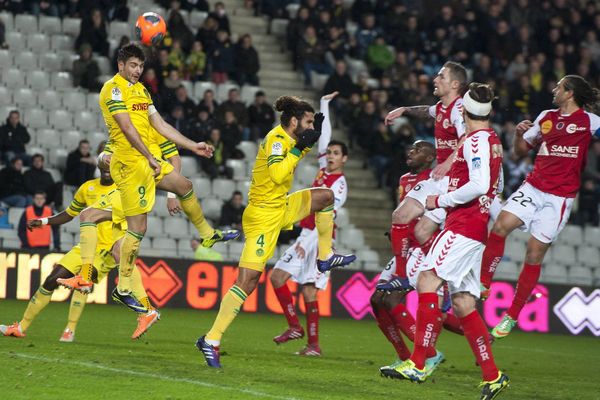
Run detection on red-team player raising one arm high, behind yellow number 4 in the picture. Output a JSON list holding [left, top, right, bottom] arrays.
[[271, 92, 348, 356]]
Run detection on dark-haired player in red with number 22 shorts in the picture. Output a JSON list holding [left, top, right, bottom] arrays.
[[481, 75, 600, 339]]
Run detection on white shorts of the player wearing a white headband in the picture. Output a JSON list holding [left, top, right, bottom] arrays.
[[421, 230, 485, 298]]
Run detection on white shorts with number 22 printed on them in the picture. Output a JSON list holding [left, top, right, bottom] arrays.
[[502, 182, 573, 243]]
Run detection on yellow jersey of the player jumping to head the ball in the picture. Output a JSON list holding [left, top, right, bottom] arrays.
[[99, 73, 155, 159]]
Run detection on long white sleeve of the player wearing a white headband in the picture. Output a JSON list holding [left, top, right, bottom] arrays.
[[438, 131, 490, 207]]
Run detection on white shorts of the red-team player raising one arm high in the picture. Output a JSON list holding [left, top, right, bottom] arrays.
[[275, 229, 329, 290]]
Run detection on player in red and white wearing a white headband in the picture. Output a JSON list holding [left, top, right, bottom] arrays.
[[384, 83, 509, 400]]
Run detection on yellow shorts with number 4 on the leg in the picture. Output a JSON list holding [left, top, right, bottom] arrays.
[[239, 189, 311, 272]]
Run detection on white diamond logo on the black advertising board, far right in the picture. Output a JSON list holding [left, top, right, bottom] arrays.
[[553, 287, 600, 336]]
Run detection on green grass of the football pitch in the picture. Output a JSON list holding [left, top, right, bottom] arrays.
[[0, 300, 600, 400]]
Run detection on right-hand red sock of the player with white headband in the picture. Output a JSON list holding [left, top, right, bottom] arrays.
[[460, 310, 498, 381]]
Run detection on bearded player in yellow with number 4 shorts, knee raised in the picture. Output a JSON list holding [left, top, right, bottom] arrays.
[[196, 96, 356, 368]]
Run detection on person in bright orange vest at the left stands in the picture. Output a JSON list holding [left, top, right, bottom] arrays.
[[18, 191, 60, 251]]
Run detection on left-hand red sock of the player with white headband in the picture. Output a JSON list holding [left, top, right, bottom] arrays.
[[410, 292, 442, 369]]
